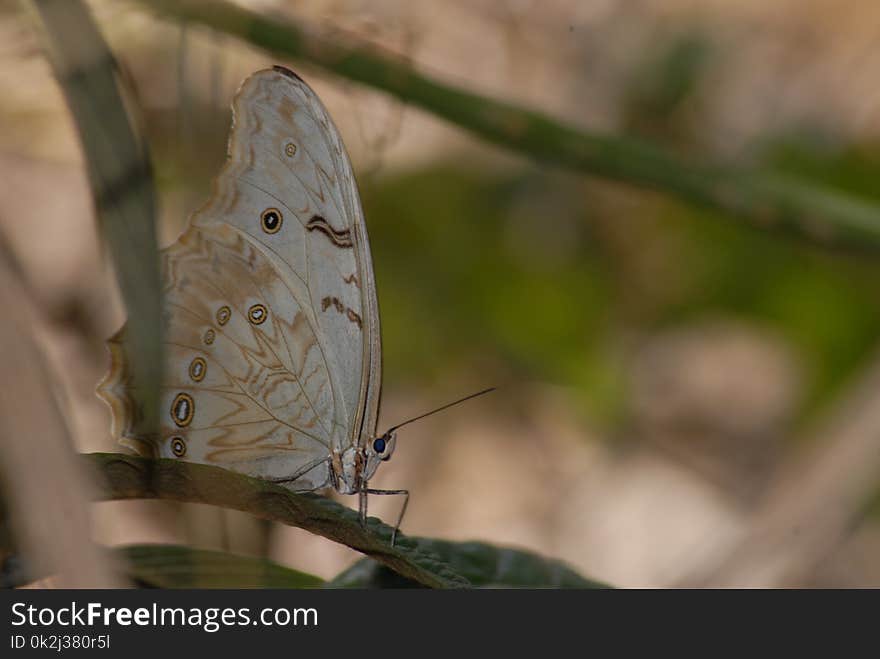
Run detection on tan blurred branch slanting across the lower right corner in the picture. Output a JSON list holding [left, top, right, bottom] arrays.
[[680, 359, 880, 587]]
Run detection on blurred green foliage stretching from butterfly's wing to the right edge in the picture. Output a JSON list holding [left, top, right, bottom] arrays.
[[365, 159, 880, 428]]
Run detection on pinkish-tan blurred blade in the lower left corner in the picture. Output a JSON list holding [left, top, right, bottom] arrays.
[[0, 245, 118, 588]]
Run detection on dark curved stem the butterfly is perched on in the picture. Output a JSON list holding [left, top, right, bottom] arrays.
[[83, 453, 470, 588]]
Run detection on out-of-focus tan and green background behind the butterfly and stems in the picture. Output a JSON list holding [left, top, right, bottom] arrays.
[[0, 0, 880, 587]]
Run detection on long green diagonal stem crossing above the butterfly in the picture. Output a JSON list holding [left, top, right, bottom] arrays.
[[136, 0, 880, 251]]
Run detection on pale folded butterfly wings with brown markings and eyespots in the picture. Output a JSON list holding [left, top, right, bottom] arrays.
[[99, 69, 381, 489]]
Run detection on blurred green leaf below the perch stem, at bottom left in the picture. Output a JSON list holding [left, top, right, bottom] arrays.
[[117, 545, 324, 588]]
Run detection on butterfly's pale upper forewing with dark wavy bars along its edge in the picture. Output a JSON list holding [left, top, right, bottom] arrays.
[[193, 69, 381, 454]]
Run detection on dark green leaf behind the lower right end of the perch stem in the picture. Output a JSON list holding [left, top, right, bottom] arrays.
[[326, 538, 609, 588]]
